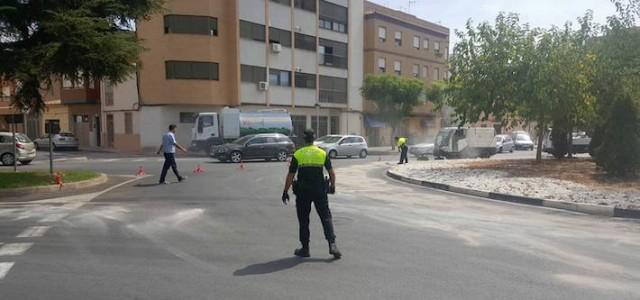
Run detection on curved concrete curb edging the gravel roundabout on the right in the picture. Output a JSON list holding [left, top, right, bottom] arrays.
[[387, 170, 640, 220]]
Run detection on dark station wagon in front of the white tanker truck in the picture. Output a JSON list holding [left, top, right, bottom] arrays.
[[209, 133, 295, 163]]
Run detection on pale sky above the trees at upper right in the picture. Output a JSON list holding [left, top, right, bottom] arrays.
[[371, 0, 616, 48]]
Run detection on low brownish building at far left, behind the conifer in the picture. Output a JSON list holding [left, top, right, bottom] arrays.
[[0, 79, 101, 147]]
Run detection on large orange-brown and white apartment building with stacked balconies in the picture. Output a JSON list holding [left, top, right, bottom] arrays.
[[102, 0, 364, 151]]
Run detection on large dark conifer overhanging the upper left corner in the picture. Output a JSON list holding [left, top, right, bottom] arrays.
[[0, 0, 163, 113]]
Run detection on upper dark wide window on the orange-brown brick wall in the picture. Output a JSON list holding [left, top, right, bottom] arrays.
[[164, 15, 218, 36]]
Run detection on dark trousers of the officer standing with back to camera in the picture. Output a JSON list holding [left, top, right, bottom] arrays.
[[296, 193, 336, 247]]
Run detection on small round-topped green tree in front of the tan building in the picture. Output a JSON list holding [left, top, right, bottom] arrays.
[[361, 75, 424, 145]]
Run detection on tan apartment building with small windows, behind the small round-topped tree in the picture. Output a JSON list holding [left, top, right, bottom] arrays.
[[364, 1, 449, 145]]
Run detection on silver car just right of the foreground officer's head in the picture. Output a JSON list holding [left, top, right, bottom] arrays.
[[313, 135, 369, 158]]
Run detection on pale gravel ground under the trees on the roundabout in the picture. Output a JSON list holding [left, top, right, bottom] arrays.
[[392, 160, 640, 209]]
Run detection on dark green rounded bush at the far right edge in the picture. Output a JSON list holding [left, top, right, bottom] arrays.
[[595, 97, 640, 177]]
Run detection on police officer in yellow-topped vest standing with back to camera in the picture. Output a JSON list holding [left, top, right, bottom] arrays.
[[282, 129, 342, 259]]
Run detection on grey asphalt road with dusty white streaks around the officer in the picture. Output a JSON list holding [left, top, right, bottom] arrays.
[[0, 157, 640, 299]]
